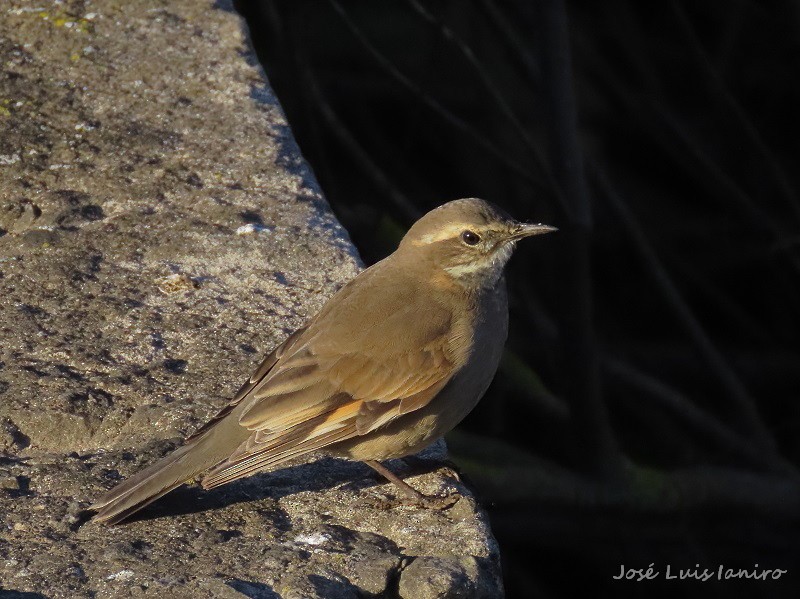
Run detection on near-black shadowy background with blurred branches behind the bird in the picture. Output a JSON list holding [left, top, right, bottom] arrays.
[[237, 0, 800, 597]]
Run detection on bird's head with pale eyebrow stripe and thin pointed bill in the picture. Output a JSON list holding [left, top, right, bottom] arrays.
[[398, 198, 557, 287]]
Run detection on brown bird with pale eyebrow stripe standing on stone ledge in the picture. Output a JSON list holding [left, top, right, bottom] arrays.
[[89, 198, 557, 524]]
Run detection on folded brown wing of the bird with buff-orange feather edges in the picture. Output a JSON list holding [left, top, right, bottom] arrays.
[[203, 294, 466, 488]]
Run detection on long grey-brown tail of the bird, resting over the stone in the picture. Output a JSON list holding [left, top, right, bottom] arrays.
[[89, 418, 249, 524]]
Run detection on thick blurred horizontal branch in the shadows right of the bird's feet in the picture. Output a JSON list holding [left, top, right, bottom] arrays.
[[450, 431, 800, 521]]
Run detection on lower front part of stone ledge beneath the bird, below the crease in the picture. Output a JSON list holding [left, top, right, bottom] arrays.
[[0, 441, 500, 599]]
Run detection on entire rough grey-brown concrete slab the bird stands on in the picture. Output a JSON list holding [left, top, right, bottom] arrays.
[[0, 0, 502, 599]]
